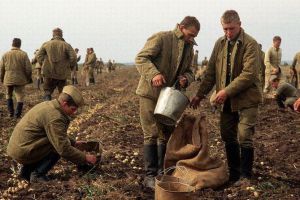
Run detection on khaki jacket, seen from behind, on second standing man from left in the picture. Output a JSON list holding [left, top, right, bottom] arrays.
[[37, 37, 76, 80]]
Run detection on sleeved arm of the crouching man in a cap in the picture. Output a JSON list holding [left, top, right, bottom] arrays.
[[45, 119, 86, 164]]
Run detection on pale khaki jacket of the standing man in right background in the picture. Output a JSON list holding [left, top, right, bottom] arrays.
[[264, 47, 282, 74]]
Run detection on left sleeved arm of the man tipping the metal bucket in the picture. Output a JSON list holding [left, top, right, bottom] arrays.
[[135, 34, 162, 82]]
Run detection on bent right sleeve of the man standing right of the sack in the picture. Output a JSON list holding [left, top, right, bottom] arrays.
[[225, 41, 260, 97]]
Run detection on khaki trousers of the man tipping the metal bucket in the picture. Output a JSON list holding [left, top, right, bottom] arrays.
[[139, 97, 174, 145]]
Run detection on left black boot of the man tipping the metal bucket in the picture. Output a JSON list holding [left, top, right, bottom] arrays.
[[144, 144, 158, 189]]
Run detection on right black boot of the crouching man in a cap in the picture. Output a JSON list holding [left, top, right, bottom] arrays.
[[30, 153, 60, 183]]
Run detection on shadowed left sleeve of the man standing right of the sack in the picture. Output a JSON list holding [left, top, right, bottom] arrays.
[[197, 41, 219, 98]]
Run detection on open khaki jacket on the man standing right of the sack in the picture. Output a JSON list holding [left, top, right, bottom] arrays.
[[197, 29, 262, 112]]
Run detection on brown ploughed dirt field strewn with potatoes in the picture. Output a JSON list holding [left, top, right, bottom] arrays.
[[0, 68, 300, 200]]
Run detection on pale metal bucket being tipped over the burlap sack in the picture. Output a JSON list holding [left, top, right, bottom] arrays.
[[154, 87, 190, 126]]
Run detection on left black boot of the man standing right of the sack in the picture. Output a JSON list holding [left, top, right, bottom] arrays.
[[225, 143, 241, 183]]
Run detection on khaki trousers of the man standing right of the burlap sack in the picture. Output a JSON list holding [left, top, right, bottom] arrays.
[[220, 101, 258, 148]]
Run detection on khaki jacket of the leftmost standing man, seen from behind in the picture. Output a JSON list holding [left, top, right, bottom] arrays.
[[0, 47, 32, 86]]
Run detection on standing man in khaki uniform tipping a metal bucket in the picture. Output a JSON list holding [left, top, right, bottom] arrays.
[[135, 16, 200, 188]]
